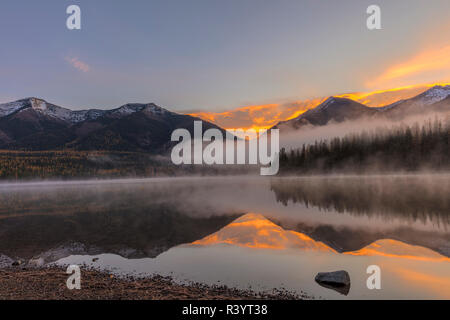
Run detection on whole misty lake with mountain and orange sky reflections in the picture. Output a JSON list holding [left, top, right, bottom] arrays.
[[0, 174, 450, 299]]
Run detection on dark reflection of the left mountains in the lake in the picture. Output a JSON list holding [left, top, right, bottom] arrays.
[[0, 205, 236, 261]]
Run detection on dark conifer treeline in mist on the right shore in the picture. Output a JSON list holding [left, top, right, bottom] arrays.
[[280, 118, 450, 174]]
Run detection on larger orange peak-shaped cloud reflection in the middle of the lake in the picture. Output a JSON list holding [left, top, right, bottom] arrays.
[[192, 213, 335, 252]]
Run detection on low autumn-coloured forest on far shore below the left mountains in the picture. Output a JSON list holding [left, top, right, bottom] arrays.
[[0, 150, 250, 180]]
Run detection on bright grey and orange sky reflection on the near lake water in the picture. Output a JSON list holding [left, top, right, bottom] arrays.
[[58, 214, 450, 299]]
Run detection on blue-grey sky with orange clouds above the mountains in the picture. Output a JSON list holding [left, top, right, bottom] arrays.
[[0, 0, 450, 127]]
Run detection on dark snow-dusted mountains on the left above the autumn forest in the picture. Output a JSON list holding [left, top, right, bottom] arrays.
[[0, 98, 224, 153]]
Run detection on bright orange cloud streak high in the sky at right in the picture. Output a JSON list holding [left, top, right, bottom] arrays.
[[367, 45, 450, 88]]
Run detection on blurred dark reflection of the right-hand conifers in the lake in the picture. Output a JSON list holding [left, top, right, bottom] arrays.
[[271, 175, 450, 225]]
